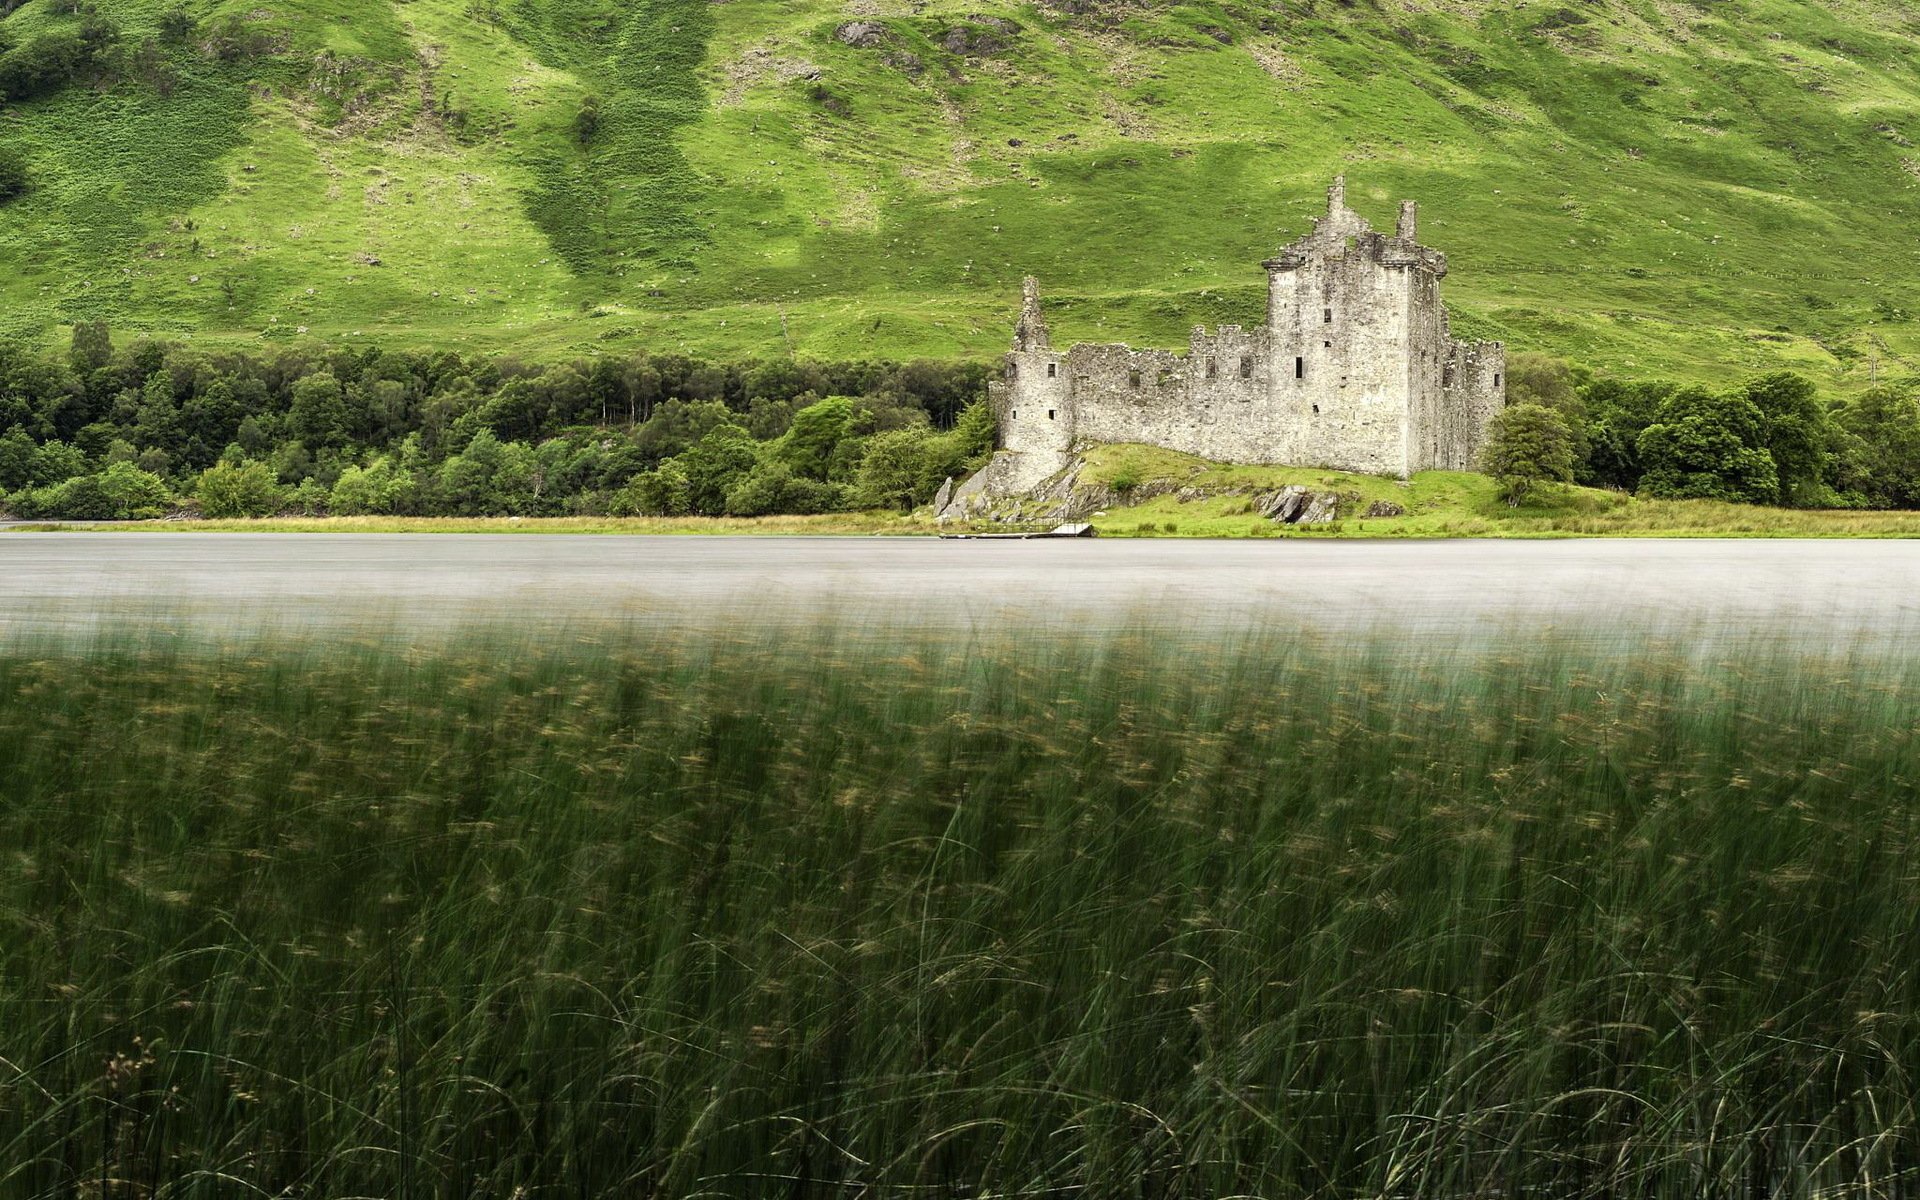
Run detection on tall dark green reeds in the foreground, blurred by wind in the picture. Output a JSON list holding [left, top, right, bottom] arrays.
[[0, 632, 1920, 1198]]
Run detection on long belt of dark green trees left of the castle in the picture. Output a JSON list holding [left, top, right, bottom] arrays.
[[0, 323, 995, 520]]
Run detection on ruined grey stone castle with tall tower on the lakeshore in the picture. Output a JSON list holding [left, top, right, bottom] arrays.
[[962, 179, 1505, 495]]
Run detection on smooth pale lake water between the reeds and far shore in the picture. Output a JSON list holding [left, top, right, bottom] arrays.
[[0, 532, 1920, 641]]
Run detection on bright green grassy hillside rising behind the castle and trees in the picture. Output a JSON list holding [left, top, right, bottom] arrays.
[[0, 0, 1920, 386]]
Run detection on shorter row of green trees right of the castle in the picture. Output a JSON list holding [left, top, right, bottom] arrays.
[[1484, 355, 1920, 509]]
